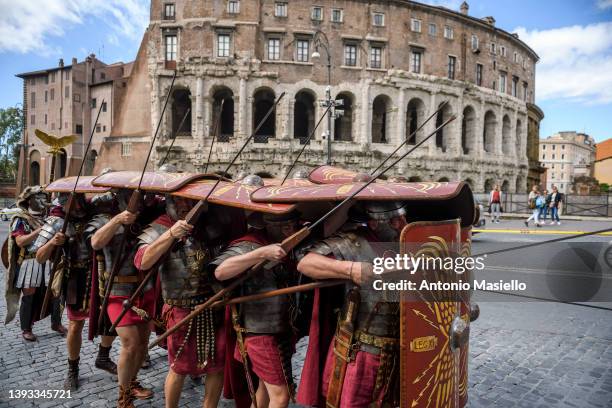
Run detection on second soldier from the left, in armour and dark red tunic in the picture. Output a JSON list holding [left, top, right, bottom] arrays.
[[33, 193, 117, 390]]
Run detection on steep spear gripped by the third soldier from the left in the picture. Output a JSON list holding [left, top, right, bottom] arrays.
[[98, 71, 185, 333]]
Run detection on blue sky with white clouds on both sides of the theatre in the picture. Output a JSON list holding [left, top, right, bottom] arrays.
[[0, 0, 612, 141]]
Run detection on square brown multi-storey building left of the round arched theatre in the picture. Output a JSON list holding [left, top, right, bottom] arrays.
[[17, 54, 131, 191]]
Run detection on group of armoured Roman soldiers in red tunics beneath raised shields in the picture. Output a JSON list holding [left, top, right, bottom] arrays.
[[7, 167, 406, 407]]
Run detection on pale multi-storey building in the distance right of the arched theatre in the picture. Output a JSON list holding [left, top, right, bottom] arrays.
[[540, 132, 595, 193]]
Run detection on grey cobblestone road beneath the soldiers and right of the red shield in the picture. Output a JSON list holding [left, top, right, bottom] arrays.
[[0, 221, 612, 408]]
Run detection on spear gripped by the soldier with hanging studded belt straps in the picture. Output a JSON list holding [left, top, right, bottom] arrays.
[[111, 92, 285, 331]]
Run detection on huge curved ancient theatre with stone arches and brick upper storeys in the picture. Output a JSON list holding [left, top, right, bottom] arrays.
[[95, 0, 542, 192]]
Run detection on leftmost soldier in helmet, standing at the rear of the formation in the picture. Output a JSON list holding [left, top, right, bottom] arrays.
[[4, 186, 66, 341]]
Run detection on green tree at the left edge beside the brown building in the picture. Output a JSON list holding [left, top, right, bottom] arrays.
[[0, 106, 23, 181]]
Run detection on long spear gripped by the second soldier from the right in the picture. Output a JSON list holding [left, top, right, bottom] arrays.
[[149, 110, 456, 348]]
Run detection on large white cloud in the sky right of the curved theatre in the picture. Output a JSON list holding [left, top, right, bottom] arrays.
[[514, 21, 612, 103]]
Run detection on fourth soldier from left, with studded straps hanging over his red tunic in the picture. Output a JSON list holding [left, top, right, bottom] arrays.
[[134, 195, 230, 407]]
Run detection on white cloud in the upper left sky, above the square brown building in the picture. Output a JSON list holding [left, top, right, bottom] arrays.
[[0, 0, 149, 55]]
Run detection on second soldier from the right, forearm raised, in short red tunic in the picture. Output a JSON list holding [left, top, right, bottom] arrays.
[[211, 212, 298, 407]]
